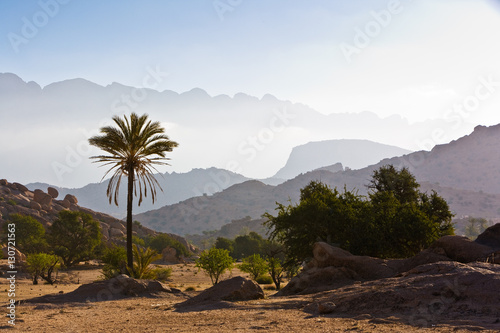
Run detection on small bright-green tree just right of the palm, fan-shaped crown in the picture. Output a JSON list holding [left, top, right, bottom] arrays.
[[196, 247, 234, 285]]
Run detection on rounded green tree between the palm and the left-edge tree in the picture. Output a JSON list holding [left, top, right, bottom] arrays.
[[48, 210, 101, 267]]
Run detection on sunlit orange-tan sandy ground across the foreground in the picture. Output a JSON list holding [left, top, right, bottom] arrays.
[[0, 264, 496, 332]]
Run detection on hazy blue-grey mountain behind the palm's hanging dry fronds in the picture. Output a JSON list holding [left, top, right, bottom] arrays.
[[26, 168, 248, 219]]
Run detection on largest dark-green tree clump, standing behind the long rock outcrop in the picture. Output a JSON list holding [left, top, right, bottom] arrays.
[[264, 166, 454, 260]]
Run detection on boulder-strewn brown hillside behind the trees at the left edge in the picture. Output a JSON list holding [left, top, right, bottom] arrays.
[[0, 179, 190, 248]]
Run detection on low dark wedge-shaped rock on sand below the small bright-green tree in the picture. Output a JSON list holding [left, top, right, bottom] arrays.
[[176, 276, 264, 308]]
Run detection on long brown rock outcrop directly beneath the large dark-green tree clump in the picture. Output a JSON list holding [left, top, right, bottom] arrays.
[[278, 224, 500, 295]]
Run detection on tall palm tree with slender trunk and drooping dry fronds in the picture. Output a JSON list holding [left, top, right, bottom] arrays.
[[89, 113, 178, 270]]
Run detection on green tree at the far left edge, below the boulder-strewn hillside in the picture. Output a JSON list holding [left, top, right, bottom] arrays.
[[3, 214, 48, 254]]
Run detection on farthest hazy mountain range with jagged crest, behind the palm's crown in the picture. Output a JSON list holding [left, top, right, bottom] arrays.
[[0, 73, 472, 187]]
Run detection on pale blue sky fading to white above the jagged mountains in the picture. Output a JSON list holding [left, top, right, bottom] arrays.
[[0, 0, 500, 185]]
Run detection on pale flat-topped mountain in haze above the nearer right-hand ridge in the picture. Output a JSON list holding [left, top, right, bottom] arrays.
[[274, 139, 411, 179]]
